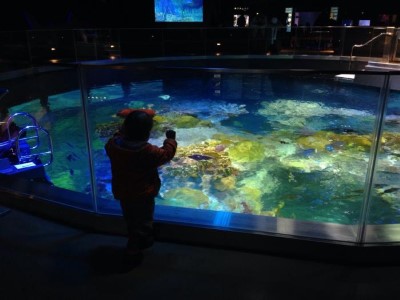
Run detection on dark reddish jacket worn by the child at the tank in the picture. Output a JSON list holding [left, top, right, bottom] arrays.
[[105, 136, 177, 200]]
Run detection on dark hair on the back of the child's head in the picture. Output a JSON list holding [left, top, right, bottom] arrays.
[[122, 111, 153, 141]]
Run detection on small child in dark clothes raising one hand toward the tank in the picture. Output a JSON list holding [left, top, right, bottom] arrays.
[[105, 110, 177, 270]]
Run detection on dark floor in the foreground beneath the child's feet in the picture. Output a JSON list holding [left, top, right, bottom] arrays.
[[0, 207, 400, 300]]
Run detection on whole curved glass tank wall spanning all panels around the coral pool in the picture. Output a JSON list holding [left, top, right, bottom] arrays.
[[0, 58, 400, 248]]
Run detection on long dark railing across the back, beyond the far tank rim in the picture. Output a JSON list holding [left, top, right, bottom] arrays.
[[0, 26, 400, 71]]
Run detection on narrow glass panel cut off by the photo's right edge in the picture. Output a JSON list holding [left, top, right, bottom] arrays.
[[365, 75, 400, 243]]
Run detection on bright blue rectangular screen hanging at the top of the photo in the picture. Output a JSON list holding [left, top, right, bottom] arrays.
[[154, 0, 203, 22]]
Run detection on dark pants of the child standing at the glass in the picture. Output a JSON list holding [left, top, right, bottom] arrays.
[[120, 198, 154, 251]]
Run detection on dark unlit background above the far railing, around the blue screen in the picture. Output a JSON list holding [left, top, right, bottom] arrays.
[[0, 0, 400, 30]]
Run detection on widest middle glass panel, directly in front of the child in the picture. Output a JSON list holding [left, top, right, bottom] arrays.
[[80, 64, 380, 241]]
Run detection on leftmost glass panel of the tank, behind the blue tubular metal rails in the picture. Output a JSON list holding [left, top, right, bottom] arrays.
[[0, 68, 93, 210]]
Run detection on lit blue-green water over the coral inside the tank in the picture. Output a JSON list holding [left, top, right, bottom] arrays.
[[13, 74, 400, 224]]
